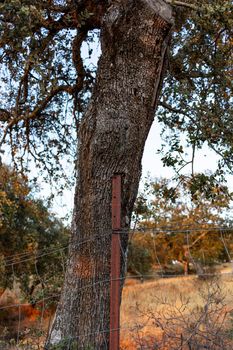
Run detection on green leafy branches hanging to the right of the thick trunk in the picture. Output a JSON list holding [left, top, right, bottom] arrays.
[[158, 0, 233, 189]]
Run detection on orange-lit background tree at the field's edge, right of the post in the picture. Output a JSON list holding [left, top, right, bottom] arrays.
[[132, 179, 232, 274]]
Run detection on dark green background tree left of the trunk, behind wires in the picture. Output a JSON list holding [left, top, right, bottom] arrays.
[[0, 165, 69, 302]]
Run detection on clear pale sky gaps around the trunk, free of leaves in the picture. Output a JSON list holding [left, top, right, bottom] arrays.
[[1, 32, 233, 221]]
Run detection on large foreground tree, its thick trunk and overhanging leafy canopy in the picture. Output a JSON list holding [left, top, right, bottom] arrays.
[[0, 0, 232, 349]]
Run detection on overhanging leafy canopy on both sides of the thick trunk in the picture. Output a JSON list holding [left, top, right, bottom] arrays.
[[0, 0, 233, 192]]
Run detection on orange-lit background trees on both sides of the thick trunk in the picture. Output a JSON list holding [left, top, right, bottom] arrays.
[[0, 170, 233, 298]]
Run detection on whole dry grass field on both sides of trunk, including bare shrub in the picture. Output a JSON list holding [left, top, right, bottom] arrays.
[[0, 268, 233, 350]]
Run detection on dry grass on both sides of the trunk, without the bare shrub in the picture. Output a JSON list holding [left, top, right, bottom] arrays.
[[0, 271, 233, 350]]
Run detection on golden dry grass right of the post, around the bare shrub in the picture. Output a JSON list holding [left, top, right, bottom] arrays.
[[121, 275, 233, 350]]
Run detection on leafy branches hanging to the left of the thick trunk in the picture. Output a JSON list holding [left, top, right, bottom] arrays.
[[0, 0, 99, 186]]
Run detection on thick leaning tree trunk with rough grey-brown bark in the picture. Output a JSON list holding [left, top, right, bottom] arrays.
[[46, 0, 172, 350]]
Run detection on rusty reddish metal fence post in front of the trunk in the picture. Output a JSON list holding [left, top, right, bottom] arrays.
[[109, 175, 121, 350]]
